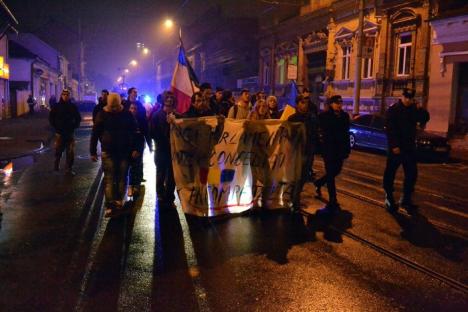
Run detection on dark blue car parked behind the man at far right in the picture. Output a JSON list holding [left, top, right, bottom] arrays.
[[349, 114, 451, 158]]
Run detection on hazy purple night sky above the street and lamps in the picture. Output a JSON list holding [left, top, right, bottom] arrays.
[[5, 0, 300, 89]]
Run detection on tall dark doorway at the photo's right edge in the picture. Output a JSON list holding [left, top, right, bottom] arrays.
[[454, 63, 468, 135]]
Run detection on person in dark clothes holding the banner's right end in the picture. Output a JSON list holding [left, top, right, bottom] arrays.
[[288, 95, 316, 211]]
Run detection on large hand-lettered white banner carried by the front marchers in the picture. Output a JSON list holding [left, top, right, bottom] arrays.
[[171, 117, 305, 216]]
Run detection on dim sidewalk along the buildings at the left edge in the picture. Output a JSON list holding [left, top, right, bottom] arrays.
[[0, 110, 53, 161]]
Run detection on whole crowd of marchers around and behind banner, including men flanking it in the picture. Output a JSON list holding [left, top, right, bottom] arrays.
[[50, 83, 429, 216]]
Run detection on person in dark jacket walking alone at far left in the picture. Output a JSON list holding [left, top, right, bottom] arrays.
[[49, 89, 81, 175]]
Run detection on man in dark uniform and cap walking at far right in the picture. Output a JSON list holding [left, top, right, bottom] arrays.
[[383, 89, 429, 214]]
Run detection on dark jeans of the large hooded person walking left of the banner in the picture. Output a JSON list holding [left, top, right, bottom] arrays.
[[102, 152, 129, 204]]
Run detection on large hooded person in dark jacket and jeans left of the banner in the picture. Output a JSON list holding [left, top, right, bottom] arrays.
[[90, 93, 140, 217]]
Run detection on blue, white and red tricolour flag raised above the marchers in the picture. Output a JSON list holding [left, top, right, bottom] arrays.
[[171, 42, 199, 113]]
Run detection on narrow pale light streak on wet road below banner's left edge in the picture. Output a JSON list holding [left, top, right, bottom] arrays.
[[177, 202, 210, 312]]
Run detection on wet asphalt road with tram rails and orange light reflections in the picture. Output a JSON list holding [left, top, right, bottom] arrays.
[[0, 128, 468, 311]]
